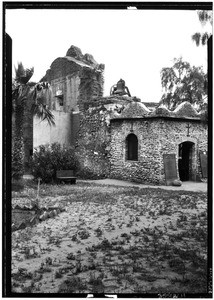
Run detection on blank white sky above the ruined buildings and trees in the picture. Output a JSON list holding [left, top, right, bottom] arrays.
[[6, 9, 211, 102]]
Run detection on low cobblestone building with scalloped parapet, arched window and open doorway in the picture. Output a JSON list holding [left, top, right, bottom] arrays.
[[110, 102, 207, 184]]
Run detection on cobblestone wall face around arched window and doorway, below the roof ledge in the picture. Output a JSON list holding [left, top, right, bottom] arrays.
[[110, 119, 207, 184]]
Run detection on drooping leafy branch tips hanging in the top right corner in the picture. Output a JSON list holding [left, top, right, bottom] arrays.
[[192, 10, 213, 46]]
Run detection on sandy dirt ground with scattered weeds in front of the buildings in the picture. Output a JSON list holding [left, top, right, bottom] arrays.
[[12, 183, 207, 294]]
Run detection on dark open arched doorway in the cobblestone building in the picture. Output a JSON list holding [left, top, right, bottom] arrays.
[[178, 142, 194, 181]]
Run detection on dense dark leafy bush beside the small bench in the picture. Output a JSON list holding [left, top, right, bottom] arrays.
[[32, 143, 78, 183]]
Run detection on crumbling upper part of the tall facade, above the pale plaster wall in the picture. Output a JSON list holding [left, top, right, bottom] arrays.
[[42, 46, 105, 112]]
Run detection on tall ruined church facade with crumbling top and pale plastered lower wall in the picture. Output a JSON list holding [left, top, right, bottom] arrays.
[[33, 46, 104, 147]]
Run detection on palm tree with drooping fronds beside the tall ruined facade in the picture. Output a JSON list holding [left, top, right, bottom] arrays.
[[12, 62, 55, 179]]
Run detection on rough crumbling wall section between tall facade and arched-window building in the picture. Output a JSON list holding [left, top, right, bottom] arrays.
[[76, 97, 131, 178]]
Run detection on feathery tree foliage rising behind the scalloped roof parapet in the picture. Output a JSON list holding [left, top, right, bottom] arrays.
[[161, 57, 207, 109]]
